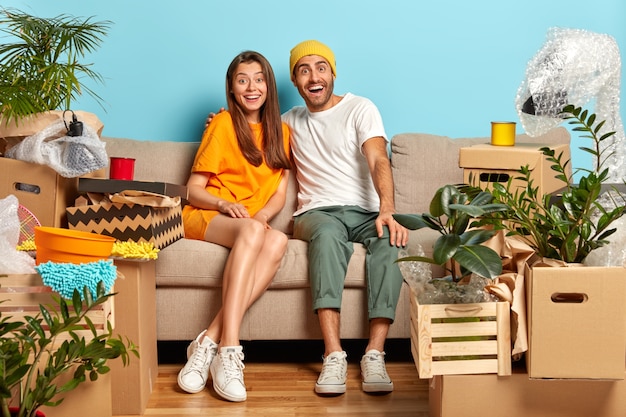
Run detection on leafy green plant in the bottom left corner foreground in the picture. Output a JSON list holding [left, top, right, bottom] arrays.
[[0, 282, 139, 417]]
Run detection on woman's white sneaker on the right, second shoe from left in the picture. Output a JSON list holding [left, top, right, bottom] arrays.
[[211, 346, 246, 402]]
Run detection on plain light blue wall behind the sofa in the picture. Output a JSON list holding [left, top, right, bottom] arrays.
[[2, 0, 626, 166]]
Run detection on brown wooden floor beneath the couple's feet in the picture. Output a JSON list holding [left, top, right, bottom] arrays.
[[127, 362, 428, 417]]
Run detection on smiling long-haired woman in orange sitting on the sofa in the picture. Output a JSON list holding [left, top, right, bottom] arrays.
[[178, 51, 290, 401]]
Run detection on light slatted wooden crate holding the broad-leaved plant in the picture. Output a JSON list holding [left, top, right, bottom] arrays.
[[410, 293, 511, 378]]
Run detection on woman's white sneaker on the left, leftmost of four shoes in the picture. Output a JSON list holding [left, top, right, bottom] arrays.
[[178, 331, 217, 394]]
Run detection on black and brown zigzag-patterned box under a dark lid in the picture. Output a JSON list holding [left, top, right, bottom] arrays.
[[67, 197, 185, 249]]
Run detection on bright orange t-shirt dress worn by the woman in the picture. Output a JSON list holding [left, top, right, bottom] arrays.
[[183, 112, 289, 240]]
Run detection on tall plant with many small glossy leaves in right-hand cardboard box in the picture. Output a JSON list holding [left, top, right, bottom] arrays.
[[481, 105, 625, 263]]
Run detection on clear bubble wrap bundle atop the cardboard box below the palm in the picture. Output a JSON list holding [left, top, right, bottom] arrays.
[[7, 120, 108, 178]]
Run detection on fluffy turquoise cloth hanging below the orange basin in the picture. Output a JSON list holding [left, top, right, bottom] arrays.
[[35, 260, 117, 299]]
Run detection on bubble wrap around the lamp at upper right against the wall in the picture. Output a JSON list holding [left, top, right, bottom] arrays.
[[515, 28, 626, 183]]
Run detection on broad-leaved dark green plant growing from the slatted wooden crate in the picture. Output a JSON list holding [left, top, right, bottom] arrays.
[[394, 185, 507, 282]]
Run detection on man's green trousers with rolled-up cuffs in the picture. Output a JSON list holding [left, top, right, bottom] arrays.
[[294, 206, 402, 321]]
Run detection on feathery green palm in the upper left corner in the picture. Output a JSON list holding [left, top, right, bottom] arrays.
[[0, 9, 111, 124]]
